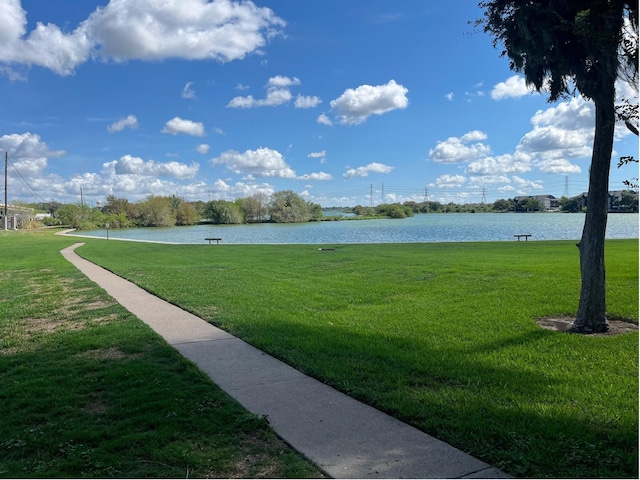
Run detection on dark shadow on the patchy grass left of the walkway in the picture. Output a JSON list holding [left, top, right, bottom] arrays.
[[0, 321, 318, 478]]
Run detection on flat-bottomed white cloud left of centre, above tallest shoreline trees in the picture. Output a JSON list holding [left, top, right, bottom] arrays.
[[210, 147, 296, 178]]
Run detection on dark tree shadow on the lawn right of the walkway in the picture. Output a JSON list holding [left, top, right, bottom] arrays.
[[239, 323, 638, 478]]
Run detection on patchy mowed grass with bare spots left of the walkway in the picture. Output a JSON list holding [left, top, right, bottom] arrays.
[[0, 232, 321, 478]]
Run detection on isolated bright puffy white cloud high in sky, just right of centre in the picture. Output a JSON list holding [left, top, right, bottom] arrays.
[[331, 80, 409, 125]]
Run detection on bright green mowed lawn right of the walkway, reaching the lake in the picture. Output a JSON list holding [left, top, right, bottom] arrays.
[[78, 240, 638, 478]]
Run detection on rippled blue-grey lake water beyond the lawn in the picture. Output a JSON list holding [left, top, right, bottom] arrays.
[[72, 213, 638, 245]]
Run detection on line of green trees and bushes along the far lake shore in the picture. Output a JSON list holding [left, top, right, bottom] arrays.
[[25, 190, 638, 230]]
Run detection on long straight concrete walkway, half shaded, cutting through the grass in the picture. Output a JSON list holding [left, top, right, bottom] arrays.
[[61, 243, 508, 478]]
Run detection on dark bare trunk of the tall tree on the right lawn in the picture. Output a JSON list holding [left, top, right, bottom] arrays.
[[570, 97, 615, 333]]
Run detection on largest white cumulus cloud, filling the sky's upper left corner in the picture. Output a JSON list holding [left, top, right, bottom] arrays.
[[0, 0, 285, 75]]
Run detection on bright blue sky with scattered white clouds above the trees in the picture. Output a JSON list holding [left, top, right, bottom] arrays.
[[0, 0, 638, 207]]
